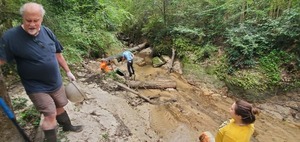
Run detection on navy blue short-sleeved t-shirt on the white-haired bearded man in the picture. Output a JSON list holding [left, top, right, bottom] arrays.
[[0, 26, 63, 94]]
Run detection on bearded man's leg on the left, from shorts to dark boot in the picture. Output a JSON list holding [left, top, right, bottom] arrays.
[[28, 93, 57, 142]]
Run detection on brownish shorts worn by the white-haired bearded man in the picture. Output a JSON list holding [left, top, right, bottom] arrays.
[[28, 85, 68, 116]]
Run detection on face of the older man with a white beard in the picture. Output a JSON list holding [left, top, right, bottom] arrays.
[[23, 8, 43, 36]]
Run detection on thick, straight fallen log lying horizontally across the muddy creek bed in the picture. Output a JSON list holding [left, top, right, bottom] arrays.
[[126, 80, 176, 89]]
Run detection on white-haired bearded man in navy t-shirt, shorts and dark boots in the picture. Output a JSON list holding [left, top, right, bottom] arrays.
[[0, 2, 82, 142]]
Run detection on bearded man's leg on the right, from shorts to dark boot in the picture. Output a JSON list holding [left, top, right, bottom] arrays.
[[51, 86, 82, 132]]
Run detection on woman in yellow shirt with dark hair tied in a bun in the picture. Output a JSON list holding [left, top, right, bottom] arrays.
[[215, 100, 259, 142]]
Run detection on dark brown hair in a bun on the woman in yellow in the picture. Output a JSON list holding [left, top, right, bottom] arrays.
[[235, 100, 259, 124]]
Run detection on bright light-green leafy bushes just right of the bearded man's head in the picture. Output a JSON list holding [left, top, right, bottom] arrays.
[[45, 0, 131, 63]]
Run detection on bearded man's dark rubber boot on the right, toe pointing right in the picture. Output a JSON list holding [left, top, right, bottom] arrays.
[[56, 111, 82, 132]]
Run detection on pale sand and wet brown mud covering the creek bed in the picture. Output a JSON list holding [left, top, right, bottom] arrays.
[[10, 59, 300, 142]]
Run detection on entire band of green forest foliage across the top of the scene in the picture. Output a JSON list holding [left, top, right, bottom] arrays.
[[0, 0, 300, 101]]
